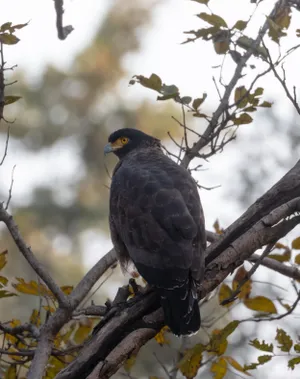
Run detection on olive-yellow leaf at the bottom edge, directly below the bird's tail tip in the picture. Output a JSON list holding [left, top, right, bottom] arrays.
[[177, 344, 205, 379]]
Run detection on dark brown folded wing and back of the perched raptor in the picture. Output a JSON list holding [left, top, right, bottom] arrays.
[[110, 162, 203, 288]]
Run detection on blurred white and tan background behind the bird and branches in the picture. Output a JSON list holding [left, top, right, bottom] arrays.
[[0, 0, 300, 378]]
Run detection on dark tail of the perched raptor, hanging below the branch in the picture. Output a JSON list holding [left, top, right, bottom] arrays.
[[159, 279, 201, 336]]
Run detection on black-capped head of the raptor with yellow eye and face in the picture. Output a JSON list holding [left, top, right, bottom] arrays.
[[104, 128, 160, 159]]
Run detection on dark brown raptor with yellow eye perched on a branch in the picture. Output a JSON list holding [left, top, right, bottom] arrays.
[[104, 128, 206, 336]]
